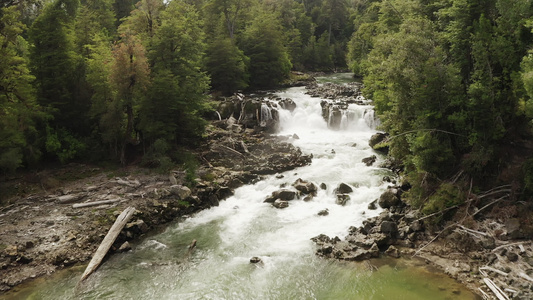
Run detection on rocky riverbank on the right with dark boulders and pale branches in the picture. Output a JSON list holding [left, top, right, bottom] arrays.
[[312, 137, 533, 299]]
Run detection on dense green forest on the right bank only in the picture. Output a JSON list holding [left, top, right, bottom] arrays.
[[347, 0, 533, 212]]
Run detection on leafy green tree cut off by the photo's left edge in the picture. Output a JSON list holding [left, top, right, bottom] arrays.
[[0, 6, 44, 172]]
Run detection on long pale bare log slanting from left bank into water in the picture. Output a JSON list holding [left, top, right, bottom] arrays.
[[79, 206, 135, 282]]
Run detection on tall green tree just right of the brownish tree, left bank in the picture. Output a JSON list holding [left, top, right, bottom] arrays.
[[140, 1, 209, 148]]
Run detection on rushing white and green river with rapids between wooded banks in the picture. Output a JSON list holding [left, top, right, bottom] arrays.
[[4, 76, 477, 300]]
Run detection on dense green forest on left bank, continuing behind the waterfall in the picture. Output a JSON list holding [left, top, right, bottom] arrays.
[[0, 0, 353, 174]]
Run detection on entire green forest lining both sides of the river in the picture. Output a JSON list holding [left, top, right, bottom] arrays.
[[0, 0, 533, 212]]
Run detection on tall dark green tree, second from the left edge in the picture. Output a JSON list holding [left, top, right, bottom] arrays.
[[29, 0, 88, 132]]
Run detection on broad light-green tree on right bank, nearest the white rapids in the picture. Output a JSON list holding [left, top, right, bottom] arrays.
[[365, 18, 460, 177]]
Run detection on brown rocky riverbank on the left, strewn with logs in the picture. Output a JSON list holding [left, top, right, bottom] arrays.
[[0, 115, 311, 292]]
